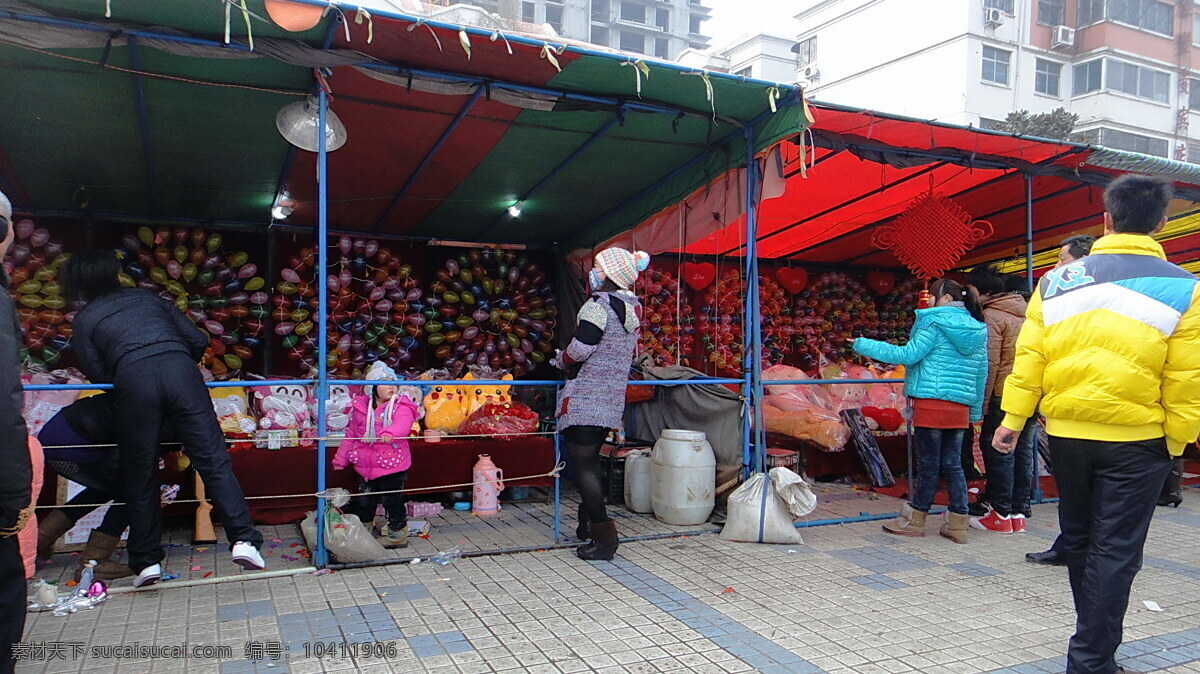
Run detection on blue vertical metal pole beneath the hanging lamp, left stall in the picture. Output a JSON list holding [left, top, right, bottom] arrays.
[[313, 89, 329, 568]]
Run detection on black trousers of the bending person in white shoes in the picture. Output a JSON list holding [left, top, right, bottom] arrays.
[[113, 354, 263, 573]]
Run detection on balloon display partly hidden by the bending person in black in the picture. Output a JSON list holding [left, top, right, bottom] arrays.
[[121, 227, 270, 378]]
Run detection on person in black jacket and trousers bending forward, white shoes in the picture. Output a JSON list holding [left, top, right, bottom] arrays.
[[65, 251, 265, 586]]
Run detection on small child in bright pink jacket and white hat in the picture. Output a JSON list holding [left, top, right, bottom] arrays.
[[334, 361, 418, 548]]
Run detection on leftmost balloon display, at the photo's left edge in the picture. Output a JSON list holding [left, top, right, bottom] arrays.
[[4, 218, 73, 368]]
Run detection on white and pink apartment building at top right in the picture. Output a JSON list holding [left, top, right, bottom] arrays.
[[787, 0, 1200, 161]]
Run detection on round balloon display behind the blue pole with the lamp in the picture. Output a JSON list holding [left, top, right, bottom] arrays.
[[271, 236, 426, 379]]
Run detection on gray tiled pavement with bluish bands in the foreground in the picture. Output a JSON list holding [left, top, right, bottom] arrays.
[[17, 488, 1200, 674]]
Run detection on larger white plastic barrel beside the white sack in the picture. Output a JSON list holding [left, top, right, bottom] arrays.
[[650, 428, 716, 524]]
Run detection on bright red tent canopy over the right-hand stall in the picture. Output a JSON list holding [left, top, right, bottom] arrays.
[[686, 103, 1200, 267]]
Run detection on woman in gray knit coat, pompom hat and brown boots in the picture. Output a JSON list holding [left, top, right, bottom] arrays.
[[557, 248, 650, 560]]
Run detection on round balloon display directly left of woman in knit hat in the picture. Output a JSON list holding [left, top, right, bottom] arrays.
[[427, 248, 558, 377]]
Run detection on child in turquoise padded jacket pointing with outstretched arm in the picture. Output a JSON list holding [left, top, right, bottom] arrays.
[[854, 278, 988, 543]]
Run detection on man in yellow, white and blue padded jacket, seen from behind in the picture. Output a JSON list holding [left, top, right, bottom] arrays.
[[992, 175, 1200, 674]]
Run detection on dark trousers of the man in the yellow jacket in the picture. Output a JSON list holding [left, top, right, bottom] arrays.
[[1050, 438, 1171, 674]]
